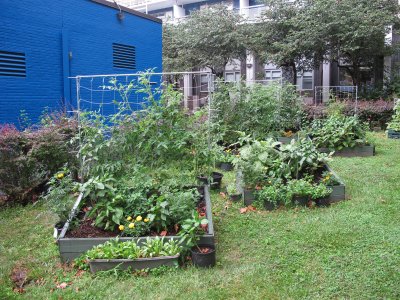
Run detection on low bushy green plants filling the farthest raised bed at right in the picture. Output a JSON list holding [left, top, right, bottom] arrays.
[[309, 115, 368, 151]]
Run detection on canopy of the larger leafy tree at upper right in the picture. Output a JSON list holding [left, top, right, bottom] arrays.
[[247, 0, 399, 84]]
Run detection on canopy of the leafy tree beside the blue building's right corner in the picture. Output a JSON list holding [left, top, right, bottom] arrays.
[[163, 5, 246, 76]]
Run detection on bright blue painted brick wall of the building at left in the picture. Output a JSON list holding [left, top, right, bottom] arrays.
[[0, 0, 162, 124]]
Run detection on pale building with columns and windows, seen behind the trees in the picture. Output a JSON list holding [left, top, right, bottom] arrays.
[[118, 0, 392, 101]]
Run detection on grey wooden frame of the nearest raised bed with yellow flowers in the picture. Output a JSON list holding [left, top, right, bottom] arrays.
[[57, 186, 215, 262]]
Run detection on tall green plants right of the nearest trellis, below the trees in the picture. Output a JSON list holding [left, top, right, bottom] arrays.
[[212, 83, 302, 144]]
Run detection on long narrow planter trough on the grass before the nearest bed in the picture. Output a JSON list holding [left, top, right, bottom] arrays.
[[89, 254, 179, 273]]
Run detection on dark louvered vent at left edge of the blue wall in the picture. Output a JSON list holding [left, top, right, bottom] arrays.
[[0, 50, 26, 77]]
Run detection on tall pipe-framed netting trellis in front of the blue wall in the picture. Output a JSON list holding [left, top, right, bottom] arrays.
[[73, 72, 213, 178]]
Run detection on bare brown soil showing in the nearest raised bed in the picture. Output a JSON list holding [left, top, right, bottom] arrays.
[[65, 200, 208, 238]]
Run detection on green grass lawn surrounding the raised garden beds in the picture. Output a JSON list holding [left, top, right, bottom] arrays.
[[0, 133, 400, 299]]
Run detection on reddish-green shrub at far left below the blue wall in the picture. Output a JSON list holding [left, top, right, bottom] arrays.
[[0, 116, 77, 203]]
